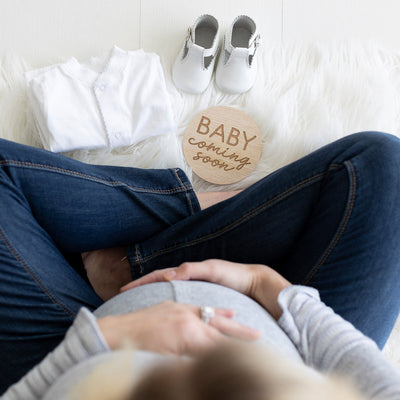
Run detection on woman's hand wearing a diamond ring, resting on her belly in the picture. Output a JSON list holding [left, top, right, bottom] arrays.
[[97, 301, 260, 354]]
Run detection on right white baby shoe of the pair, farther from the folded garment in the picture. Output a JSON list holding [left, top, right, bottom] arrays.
[[215, 15, 260, 94]]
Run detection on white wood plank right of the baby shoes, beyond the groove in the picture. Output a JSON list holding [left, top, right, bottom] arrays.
[[282, 0, 400, 50]]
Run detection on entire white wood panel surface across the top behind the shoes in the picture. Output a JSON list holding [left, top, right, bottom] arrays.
[[0, 0, 400, 66]]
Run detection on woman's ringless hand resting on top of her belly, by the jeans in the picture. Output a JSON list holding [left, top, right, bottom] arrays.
[[121, 260, 290, 319]]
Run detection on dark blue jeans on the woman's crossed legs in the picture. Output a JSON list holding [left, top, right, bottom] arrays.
[[0, 132, 400, 393]]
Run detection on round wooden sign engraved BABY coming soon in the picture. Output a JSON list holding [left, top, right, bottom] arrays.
[[183, 106, 261, 185]]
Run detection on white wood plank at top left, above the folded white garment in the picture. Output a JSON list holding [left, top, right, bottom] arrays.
[[0, 0, 145, 66]]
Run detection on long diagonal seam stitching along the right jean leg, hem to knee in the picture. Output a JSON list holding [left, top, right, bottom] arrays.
[[133, 165, 340, 263]]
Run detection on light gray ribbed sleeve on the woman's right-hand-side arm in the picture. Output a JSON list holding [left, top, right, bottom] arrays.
[[278, 286, 400, 400]]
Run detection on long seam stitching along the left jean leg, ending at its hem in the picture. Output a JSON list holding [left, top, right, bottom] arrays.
[[0, 160, 187, 194]]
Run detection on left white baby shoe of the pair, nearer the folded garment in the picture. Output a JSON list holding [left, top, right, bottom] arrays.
[[172, 15, 219, 94]]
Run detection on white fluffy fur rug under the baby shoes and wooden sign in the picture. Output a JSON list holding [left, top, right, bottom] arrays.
[[0, 42, 400, 367]]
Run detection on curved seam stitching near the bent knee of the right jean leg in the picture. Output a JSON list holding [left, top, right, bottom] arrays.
[[302, 161, 357, 285]]
